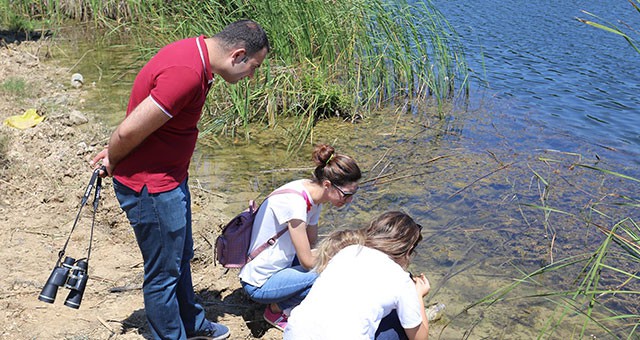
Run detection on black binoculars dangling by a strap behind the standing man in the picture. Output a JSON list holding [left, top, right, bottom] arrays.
[[38, 256, 89, 309]]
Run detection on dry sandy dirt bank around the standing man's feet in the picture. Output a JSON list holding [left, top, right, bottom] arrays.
[[0, 41, 282, 339]]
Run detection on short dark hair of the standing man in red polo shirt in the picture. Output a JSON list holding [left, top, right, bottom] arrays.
[[214, 20, 270, 57]]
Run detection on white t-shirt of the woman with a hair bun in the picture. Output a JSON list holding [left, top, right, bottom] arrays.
[[239, 179, 322, 287]]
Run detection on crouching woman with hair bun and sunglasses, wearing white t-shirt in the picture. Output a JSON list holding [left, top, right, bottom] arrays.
[[240, 144, 362, 330]]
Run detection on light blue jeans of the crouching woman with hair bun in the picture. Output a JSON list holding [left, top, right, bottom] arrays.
[[242, 265, 318, 310]]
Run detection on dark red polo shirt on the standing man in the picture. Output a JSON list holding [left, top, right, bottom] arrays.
[[114, 36, 213, 193]]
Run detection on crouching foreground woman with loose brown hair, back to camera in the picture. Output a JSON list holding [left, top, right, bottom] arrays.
[[284, 211, 430, 340]]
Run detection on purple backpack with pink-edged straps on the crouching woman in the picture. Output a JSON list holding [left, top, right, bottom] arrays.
[[214, 189, 311, 268]]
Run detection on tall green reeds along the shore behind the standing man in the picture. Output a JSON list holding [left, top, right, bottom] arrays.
[[0, 0, 468, 148]]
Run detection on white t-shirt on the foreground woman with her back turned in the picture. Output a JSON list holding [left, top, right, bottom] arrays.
[[284, 245, 422, 340]]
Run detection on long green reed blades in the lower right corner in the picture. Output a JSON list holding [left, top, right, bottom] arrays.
[[465, 159, 640, 339]]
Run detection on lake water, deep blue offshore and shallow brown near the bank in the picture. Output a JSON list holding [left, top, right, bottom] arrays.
[[66, 0, 640, 339]]
